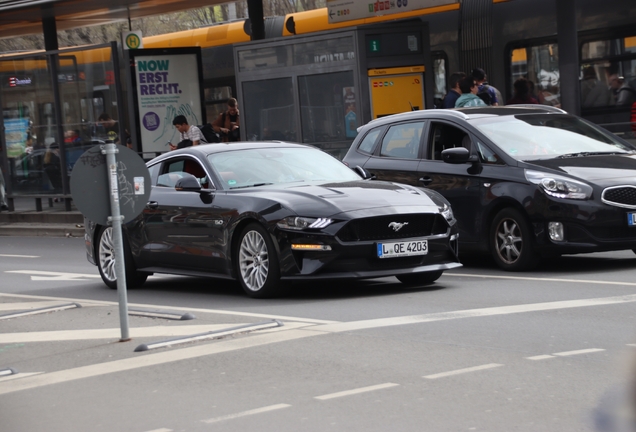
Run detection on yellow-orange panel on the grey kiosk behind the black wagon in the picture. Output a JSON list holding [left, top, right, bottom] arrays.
[[368, 66, 424, 119]]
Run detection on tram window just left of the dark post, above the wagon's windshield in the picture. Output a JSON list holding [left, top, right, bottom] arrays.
[[510, 44, 561, 107]]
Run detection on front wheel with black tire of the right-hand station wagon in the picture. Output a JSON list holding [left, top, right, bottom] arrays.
[[490, 208, 539, 271]]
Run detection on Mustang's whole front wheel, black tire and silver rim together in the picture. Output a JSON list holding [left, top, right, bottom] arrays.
[[234, 223, 282, 298]]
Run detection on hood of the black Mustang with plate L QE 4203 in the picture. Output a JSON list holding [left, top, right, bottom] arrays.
[[241, 181, 443, 217]]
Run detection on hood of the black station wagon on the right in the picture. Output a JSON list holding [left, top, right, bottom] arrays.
[[527, 155, 636, 187]]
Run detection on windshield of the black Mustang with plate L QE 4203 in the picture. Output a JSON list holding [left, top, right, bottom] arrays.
[[208, 148, 360, 189]]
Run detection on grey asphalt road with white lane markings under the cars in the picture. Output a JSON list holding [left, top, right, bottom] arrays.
[[0, 237, 636, 432]]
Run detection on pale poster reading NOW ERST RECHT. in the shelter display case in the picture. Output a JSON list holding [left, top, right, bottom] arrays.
[[134, 50, 204, 152]]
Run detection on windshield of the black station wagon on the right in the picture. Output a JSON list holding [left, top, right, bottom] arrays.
[[473, 114, 635, 160]]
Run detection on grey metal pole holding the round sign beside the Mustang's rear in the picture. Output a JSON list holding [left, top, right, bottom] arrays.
[[102, 143, 130, 342]]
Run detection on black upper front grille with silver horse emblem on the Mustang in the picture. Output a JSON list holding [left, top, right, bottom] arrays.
[[337, 213, 448, 242]]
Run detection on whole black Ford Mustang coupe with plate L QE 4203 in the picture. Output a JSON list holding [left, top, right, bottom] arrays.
[[86, 142, 461, 297]]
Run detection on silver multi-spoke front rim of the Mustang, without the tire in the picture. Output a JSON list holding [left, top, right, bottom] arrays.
[[239, 230, 269, 291]]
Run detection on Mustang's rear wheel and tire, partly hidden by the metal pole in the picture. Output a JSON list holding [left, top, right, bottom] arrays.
[[95, 227, 148, 289]]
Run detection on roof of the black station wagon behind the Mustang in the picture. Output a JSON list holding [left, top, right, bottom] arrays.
[[358, 104, 567, 132]]
